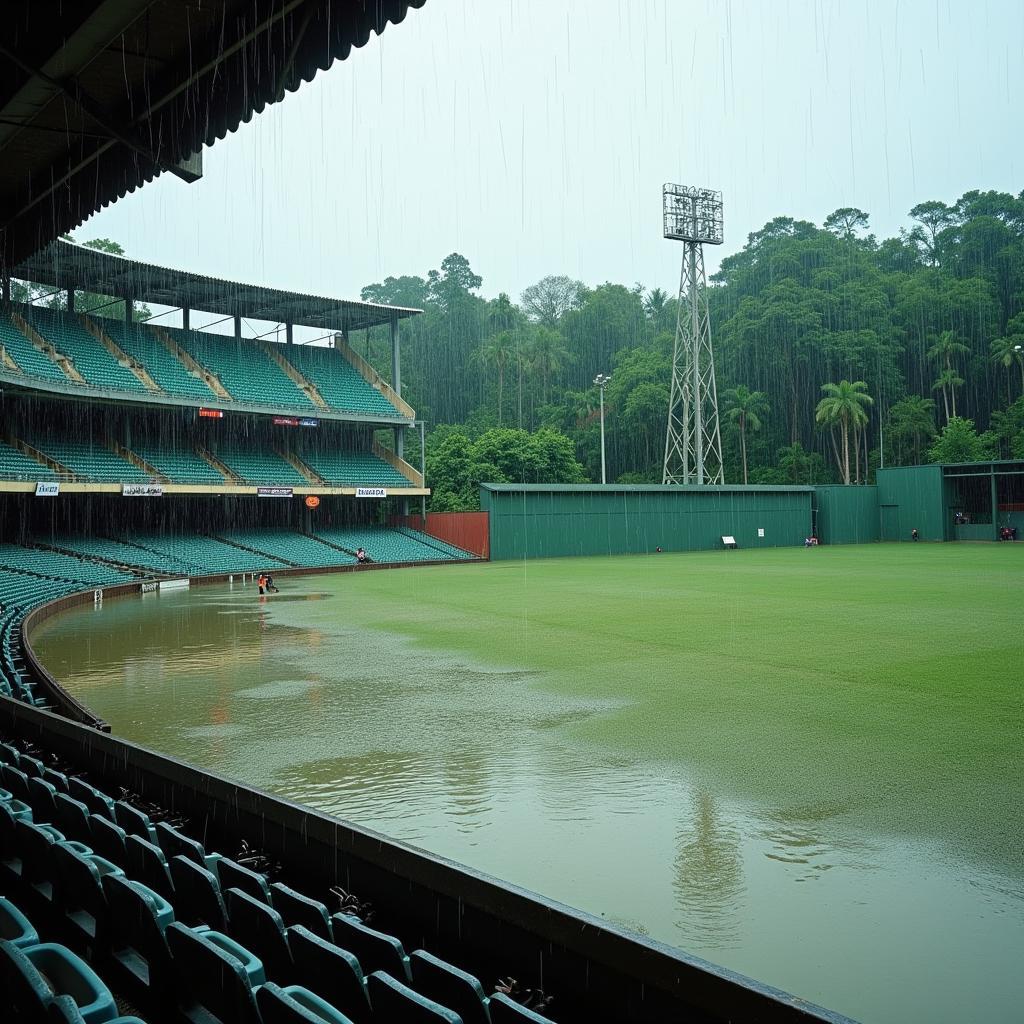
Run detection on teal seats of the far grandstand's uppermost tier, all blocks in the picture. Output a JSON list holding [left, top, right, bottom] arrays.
[[0, 306, 399, 418]]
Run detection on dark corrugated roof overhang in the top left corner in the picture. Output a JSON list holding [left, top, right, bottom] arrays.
[[0, 0, 425, 271]]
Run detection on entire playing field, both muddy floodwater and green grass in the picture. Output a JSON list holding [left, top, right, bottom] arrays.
[[34, 545, 1024, 1021]]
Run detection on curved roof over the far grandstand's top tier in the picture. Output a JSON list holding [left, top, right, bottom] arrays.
[[12, 242, 423, 334]]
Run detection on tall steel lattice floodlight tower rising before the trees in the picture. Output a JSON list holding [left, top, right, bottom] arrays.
[[662, 184, 723, 483]]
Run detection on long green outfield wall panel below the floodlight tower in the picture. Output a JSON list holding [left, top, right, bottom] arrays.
[[480, 483, 814, 561]]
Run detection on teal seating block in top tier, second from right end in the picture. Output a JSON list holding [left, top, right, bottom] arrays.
[[167, 328, 316, 412]]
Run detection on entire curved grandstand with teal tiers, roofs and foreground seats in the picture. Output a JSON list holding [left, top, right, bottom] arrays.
[[0, 0, 840, 1024]]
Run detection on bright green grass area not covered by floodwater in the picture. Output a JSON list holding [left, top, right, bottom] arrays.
[[344, 544, 1024, 870]]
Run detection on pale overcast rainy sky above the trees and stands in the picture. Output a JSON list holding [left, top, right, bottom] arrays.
[[76, 0, 1024, 298]]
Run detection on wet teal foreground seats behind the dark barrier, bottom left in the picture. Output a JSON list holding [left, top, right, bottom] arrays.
[[0, 743, 550, 1024]]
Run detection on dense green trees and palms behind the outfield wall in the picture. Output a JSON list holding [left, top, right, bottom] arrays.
[[353, 191, 1024, 508]]
